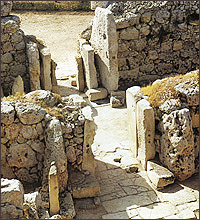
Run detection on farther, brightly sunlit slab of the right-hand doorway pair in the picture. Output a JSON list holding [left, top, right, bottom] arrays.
[[126, 86, 141, 157]]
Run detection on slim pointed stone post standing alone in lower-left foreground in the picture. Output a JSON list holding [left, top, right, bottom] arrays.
[[49, 162, 60, 216]]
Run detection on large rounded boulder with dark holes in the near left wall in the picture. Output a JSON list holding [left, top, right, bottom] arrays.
[[7, 143, 38, 168]]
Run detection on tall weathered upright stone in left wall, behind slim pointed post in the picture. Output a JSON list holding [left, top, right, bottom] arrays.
[[42, 119, 68, 192]]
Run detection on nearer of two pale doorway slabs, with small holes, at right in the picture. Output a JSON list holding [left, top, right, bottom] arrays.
[[136, 99, 155, 170]]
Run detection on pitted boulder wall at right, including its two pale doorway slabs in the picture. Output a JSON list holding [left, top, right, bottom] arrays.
[[126, 71, 199, 181]]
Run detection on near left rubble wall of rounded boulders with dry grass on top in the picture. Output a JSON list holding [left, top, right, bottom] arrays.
[[1, 90, 94, 191]]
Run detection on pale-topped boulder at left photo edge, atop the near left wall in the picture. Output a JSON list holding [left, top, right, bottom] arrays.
[[1, 101, 15, 125]]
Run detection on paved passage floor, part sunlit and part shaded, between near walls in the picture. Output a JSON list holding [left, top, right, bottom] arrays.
[[76, 104, 199, 219]]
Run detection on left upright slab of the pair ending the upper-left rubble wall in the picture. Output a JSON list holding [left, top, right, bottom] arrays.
[[26, 42, 40, 91]]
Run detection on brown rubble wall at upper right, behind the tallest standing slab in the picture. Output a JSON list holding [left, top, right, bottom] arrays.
[[108, 1, 199, 89]]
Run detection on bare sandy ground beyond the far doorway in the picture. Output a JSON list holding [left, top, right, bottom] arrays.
[[12, 11, 94, 79]]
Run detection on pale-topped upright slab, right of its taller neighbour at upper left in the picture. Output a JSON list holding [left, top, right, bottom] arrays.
[[40, 47, 52, 91]]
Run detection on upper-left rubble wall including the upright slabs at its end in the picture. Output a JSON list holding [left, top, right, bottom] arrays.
[[1, 1, 56, 96]]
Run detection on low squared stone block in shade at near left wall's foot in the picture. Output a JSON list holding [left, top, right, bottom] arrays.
[[69, 174, 100, 199]]
